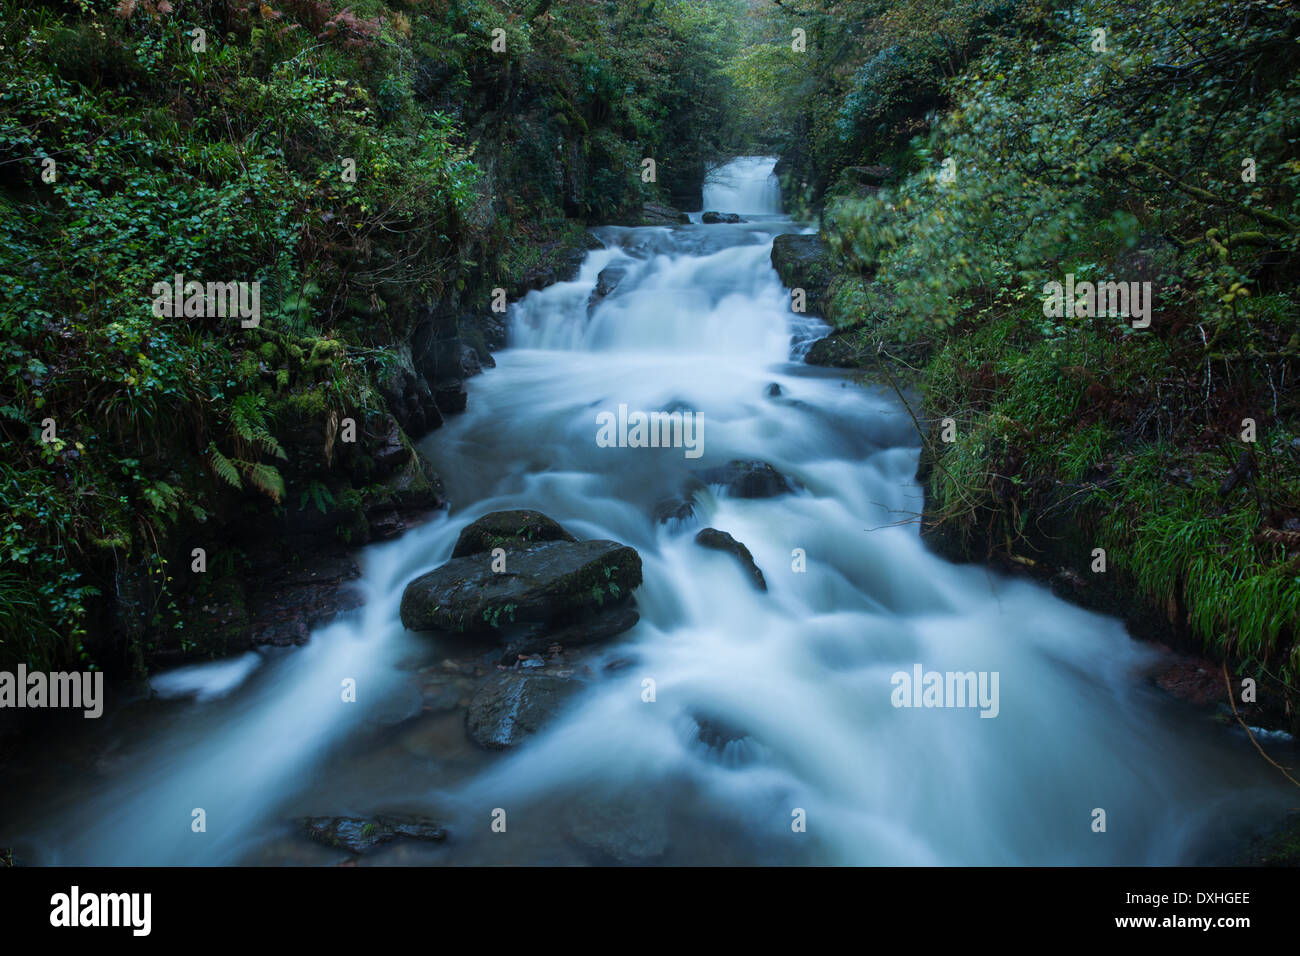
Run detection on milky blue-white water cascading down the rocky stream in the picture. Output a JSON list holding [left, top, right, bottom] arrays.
[[0, 159, 1294, 865]]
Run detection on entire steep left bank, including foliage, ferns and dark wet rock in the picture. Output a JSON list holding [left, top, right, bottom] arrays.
[[0, 0, 754, 675]]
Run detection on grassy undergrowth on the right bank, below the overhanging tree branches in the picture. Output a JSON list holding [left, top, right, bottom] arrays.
[[924, 300, 1300, 684]]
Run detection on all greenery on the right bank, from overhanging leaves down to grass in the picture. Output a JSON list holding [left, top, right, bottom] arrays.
[[796, 0, 1300, 687]]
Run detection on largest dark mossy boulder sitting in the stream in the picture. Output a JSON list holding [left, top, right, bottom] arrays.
[[402, 538, 641, 633]]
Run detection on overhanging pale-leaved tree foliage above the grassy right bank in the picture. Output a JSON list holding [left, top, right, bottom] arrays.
[[828, 0, 1300, 334]]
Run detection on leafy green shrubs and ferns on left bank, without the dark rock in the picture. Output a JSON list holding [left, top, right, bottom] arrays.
[[0, 3, 477, 666]]
